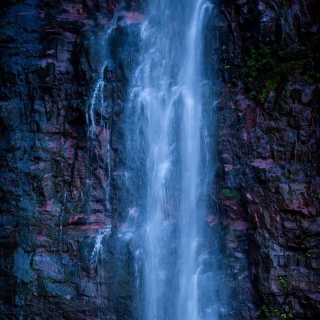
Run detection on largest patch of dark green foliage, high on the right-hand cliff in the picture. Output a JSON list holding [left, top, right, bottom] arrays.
[[242, 44, 320, 101]]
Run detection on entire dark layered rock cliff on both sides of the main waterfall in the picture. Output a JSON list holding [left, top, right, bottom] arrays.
[[0, 0, 320, 319]]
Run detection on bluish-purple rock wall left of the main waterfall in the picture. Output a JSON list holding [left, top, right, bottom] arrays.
[[0, 0, 142, 319]]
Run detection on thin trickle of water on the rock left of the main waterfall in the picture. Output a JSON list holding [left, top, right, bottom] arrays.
[[86, 8, 121, 319]]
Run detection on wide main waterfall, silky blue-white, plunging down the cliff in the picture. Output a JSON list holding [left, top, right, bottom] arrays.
[[126, 0, 216, 320]]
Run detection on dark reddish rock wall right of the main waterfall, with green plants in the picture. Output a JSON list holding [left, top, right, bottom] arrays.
[[218, 0, 320, 319]]
